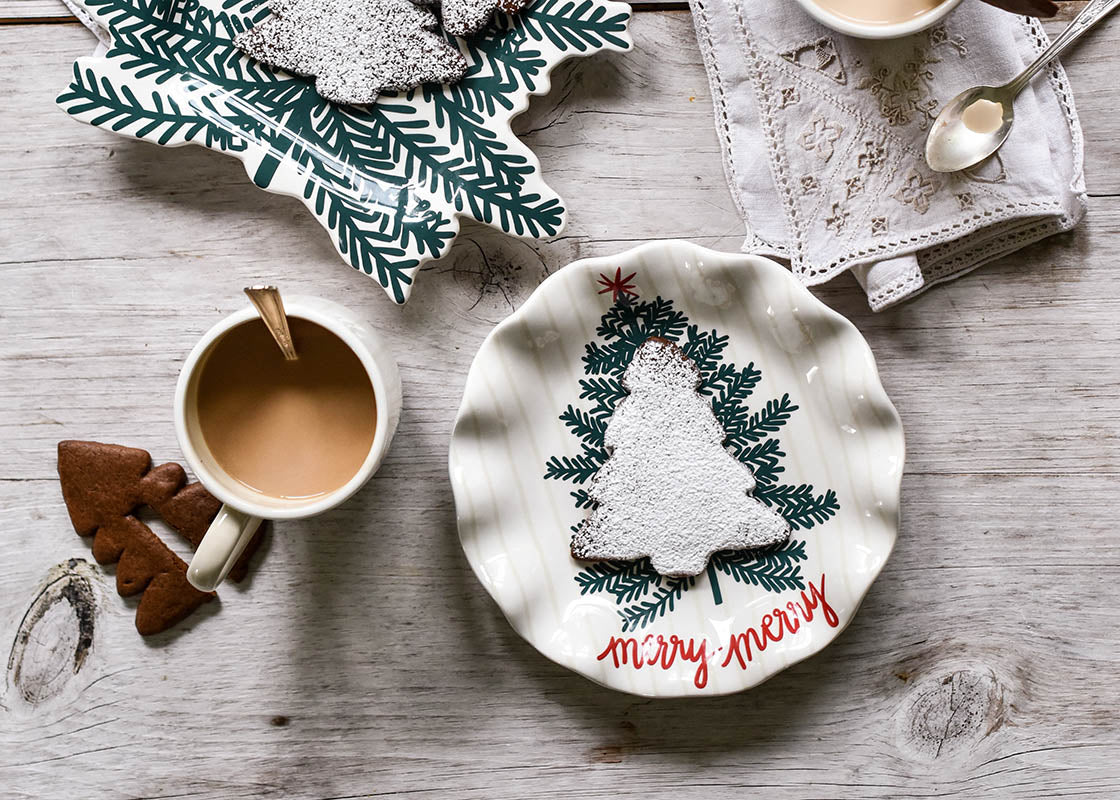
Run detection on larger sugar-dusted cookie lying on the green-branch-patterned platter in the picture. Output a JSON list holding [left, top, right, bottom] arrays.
[[234, 0, 467, 104]]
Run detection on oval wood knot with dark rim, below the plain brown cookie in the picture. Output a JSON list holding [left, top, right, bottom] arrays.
[[8, 558, 97, 706]]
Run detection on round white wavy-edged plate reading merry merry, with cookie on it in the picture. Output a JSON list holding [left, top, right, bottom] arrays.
[[450, 242, 904, 697]]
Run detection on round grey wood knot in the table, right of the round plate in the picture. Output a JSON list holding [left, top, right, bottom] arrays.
[[903, 668, 1006, 760]]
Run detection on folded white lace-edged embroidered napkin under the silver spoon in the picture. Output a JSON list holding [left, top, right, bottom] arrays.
[[691, 0, 1085, 310]]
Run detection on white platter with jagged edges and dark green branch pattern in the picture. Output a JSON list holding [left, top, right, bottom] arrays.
[[57, 0, 632, 303]]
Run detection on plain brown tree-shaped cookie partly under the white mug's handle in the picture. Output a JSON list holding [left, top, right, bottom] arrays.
[[58, 441, 264, 635]]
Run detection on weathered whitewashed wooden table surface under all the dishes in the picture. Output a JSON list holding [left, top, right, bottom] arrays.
[[0, 0, 1120, 800]]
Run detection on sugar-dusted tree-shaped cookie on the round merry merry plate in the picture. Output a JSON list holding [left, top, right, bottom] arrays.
[[571, 337, 790, 576]]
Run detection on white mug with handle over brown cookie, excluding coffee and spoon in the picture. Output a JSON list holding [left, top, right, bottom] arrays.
[[175, 296, 401, 592]]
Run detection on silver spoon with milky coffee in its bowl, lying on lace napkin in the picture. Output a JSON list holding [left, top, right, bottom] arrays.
[[925, 0, 1120, 173]]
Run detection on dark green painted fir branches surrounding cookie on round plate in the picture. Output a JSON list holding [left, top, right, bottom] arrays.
[[544, 296, 840, 632]]
